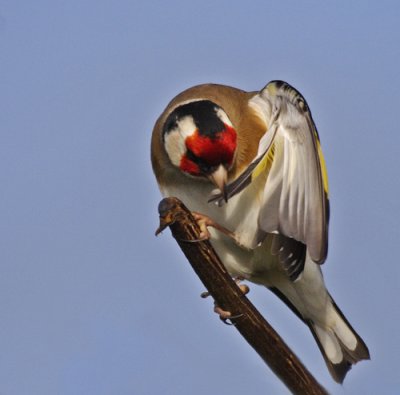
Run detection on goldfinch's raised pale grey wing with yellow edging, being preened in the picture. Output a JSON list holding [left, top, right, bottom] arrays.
[[212, 81, 329, 263]]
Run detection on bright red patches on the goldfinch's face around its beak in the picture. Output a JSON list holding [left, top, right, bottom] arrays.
[[180, 124, 236, 175]]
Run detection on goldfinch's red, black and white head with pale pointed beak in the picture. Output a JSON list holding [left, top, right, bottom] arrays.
[[163, 100, 236, 198]]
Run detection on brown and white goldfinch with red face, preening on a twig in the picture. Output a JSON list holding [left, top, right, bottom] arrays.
[[151, 80, 370, 383]]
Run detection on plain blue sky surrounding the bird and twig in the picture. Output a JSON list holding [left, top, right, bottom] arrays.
[[0, 0, 400, 395]]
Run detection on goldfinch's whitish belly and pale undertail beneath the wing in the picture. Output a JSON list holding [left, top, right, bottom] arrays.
[[162, 180, 357, 363]]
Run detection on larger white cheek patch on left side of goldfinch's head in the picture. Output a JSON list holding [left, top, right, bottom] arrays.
[[164, 116, 196, 167]]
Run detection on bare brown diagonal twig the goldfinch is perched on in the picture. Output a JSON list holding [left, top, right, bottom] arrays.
[[156, 198, 327, 395]]
